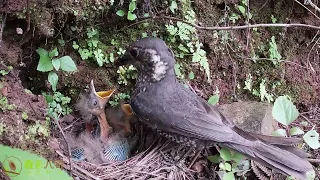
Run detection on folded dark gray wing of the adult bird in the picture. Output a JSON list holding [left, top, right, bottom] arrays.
[[131, 83, 245, 142]]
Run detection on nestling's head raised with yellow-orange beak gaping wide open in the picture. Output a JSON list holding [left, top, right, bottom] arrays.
[[76, 80, 116, 116]]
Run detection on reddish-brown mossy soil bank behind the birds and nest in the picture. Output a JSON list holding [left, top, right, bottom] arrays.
[[0, 0, 320, 179]]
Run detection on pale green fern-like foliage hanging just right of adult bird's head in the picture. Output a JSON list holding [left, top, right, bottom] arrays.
[[166, 9, 211, 82]]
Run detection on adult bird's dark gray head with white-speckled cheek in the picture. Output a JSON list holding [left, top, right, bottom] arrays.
[[117, 37, 175, 81]]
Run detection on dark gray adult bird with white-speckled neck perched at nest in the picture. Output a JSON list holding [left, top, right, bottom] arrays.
[[118, 37, 314, 179]]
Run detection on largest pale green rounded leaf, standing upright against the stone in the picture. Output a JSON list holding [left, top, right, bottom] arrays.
[[272, 96, 299, 125]]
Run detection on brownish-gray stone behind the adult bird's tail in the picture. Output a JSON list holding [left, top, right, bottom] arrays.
[[217, 101, 279, 135]]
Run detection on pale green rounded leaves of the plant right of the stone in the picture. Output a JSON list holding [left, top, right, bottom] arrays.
[[272, 96, 320, 149]]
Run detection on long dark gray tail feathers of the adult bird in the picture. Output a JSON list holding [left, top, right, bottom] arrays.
[[222, 134, 314, 180]]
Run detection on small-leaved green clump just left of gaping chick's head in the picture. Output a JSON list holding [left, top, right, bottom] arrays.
[[43, 92, 72, 119]]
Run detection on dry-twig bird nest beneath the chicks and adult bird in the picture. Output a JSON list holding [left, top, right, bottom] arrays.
[[51, 118, 204, 180]]
